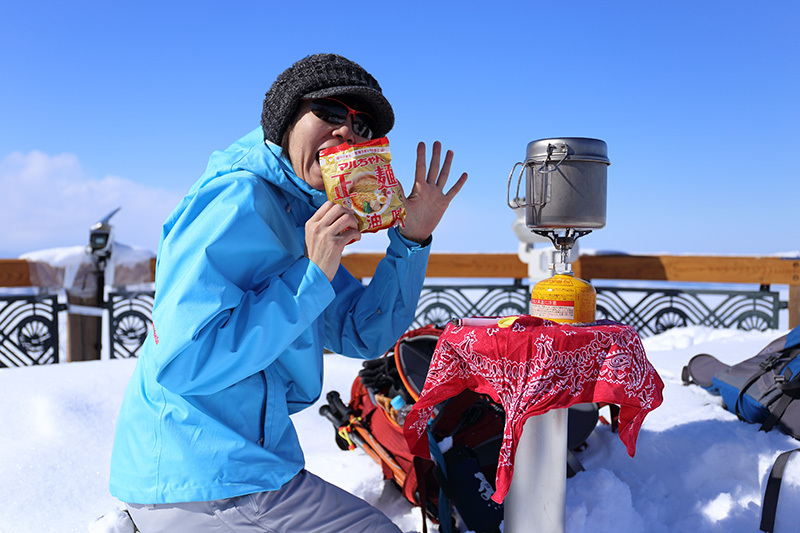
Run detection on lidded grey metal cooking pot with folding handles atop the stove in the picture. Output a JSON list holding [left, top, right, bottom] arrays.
[[506, 137, 611, 230]]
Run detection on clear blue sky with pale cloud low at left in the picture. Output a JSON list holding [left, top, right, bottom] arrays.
[[0, 0, 800, 257]]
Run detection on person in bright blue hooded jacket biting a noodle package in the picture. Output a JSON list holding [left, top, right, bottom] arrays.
[[110, 54, 467, 533]]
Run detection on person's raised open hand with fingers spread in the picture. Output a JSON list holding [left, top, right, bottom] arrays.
[[399, 141, 467, 243]]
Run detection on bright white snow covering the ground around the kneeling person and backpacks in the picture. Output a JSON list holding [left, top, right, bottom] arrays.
[[0, 327, 800, 533]]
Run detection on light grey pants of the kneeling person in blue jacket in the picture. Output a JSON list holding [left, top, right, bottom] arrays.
[[126, 470, 401, 533]]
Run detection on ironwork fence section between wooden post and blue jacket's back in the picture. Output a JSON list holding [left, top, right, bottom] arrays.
[[108, 291, 155, 359]]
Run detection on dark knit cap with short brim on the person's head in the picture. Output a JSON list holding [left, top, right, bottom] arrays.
[[261, 54, 394, 144]]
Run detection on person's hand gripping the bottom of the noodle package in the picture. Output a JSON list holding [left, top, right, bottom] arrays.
[[306, 201, 361, 281]]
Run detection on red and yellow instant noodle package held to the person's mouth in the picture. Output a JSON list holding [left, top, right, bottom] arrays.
[[319, 137, 406, 233]]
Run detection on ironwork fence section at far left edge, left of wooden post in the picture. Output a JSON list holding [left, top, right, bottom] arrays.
[[0, 295, 66, 368]]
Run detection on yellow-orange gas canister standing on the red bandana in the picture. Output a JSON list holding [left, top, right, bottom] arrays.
[[531, 270, 597, 324]]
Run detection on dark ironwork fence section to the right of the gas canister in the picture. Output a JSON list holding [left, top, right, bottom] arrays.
[[595, 287, 783, 337]]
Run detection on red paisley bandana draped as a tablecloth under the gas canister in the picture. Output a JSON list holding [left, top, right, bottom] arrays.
[[404, 316, 664, 502]]
